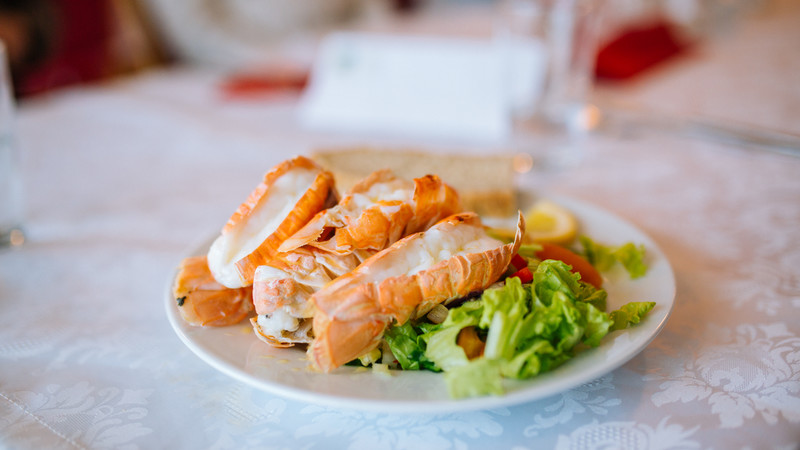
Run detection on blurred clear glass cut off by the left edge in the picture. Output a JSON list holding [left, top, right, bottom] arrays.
[[0, 41, 25, 247]]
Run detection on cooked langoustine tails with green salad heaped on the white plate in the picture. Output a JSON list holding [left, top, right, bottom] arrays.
[[172, 156, 654, 397]]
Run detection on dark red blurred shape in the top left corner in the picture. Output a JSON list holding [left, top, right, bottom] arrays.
[[16, 0, 113, 96]]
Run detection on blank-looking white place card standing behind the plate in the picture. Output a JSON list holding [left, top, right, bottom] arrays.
[[300, 33, 536, 141]]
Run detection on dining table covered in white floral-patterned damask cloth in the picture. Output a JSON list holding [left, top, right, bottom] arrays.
[[0, 1, 800, 450]]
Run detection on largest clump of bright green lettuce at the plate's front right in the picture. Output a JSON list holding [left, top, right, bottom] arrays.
[[422, 260, 614, 398]]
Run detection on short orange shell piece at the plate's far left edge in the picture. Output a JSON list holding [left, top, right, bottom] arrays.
[[172, 256, 253, 327]]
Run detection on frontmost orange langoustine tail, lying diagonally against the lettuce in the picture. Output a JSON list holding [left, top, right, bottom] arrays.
[[308, 213, 525, 372]]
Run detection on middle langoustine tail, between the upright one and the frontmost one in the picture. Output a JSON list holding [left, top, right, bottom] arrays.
[[251, 170, 460, 347]]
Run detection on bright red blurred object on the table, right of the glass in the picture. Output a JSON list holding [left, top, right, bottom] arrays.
[[595, 22, 688, 80]]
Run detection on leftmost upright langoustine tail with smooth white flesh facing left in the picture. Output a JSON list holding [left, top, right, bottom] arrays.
[[207, 156, 338, 288]]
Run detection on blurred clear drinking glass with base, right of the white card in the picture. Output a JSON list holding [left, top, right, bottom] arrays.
[[495, 0, 605, 174]]
